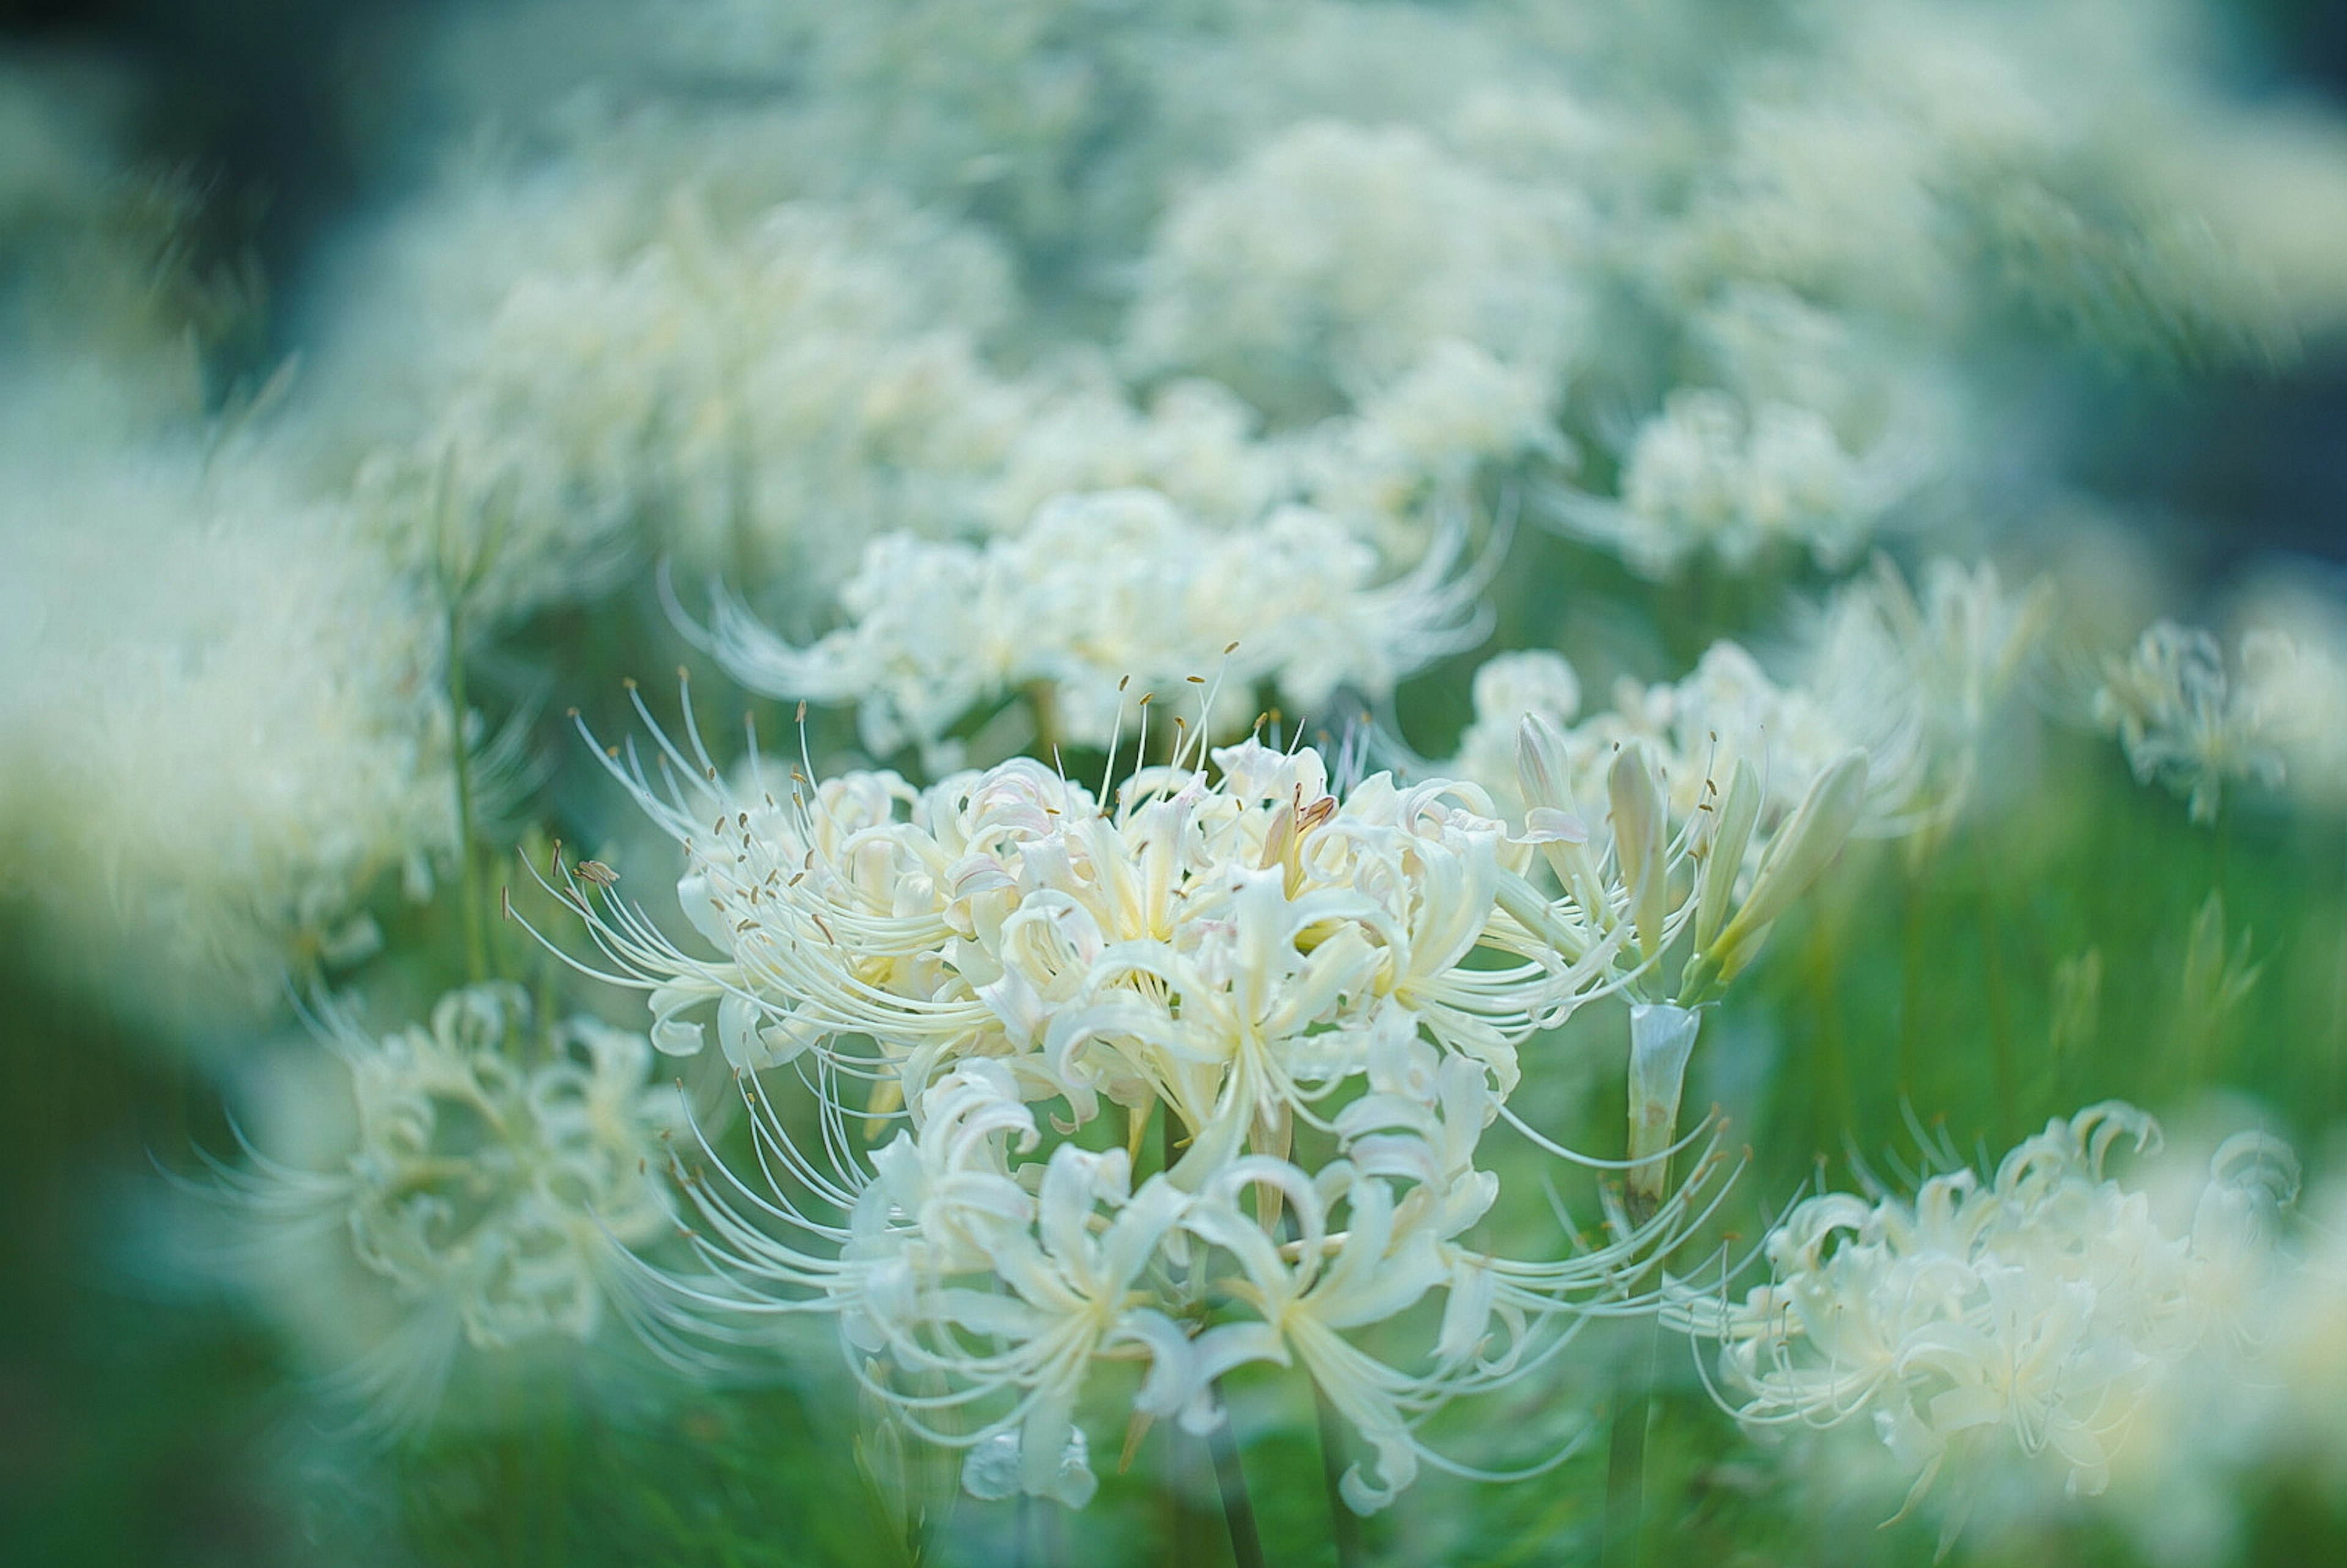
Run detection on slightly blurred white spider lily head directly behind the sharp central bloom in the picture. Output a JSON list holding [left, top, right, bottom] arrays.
[[685, 491, 1483, 770]]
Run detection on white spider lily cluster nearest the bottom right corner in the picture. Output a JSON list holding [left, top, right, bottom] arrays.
[[1678, 1101, 2297, 1533]]
